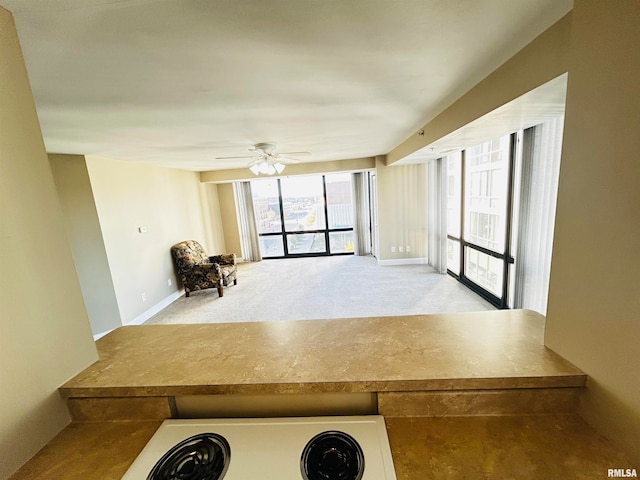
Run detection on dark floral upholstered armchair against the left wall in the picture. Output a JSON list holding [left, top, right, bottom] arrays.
[[171, 240, 238, 297]]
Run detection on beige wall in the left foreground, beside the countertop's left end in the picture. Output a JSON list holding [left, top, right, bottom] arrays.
[[0, 8, 97, 479]]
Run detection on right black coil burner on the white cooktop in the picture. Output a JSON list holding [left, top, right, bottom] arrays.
[[300, 431, 364, 480]]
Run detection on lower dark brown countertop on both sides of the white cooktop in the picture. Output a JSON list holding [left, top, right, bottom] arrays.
[[10, 415, 637, 480]]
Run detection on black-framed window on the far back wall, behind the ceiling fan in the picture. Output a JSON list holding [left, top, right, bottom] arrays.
[[251, 173, 353, 258]]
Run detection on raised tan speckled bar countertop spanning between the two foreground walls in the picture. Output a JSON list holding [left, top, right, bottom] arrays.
[[61, 310, 586, 397]]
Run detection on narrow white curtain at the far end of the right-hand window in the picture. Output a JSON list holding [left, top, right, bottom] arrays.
[[427, 158, 447, 273]]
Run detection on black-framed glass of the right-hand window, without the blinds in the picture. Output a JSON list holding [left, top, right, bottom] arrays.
[[447, 134, 516, 307]]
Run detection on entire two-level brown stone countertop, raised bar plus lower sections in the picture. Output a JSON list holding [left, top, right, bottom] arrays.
[[11, 310, 634, 480]]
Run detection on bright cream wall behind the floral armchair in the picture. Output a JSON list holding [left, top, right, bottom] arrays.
[[86, 156, 215, 324]]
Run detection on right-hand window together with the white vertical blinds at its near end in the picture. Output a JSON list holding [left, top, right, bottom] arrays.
[[439, 117, 563, 315]]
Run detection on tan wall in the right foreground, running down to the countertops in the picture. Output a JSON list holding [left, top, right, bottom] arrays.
[[545, 0, 640, 462]]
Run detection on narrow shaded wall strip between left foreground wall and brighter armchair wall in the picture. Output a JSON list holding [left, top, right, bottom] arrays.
[[49, 155, 122, 335]]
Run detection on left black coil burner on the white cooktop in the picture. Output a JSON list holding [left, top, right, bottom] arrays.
[[147, 433, 231, 480]]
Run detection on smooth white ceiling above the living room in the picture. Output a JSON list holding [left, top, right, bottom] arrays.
[[0, 0, 573, 171]]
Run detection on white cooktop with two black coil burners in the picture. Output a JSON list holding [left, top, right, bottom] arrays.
[[123, 415, 396, 480]]
